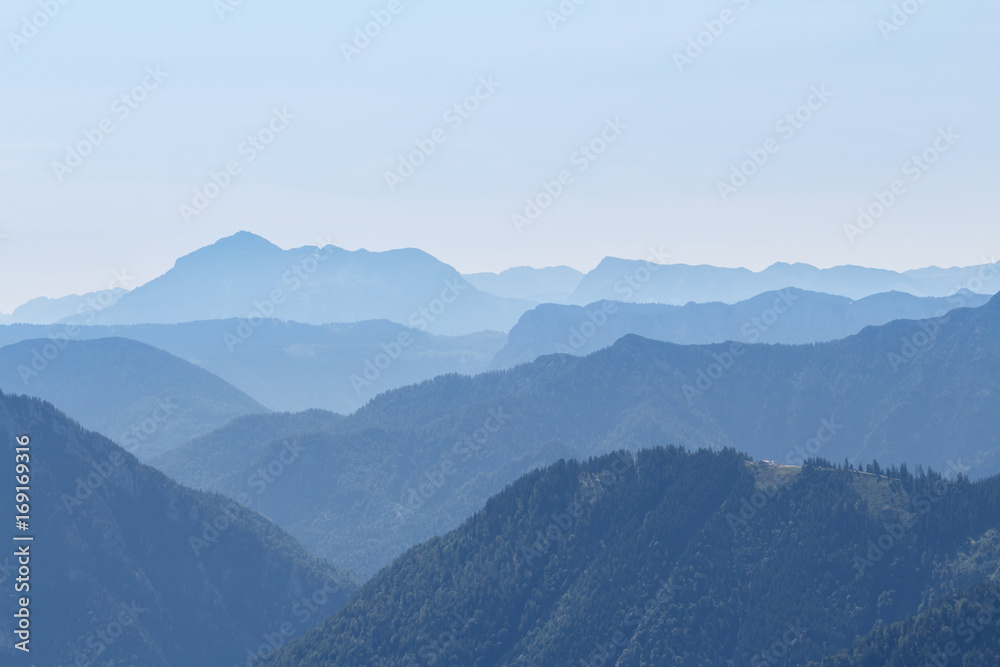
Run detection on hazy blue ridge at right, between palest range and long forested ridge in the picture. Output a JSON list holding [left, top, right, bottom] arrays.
[[490, 288, 990, 369]]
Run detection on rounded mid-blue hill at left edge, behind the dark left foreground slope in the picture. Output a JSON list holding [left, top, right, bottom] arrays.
[[0, 338, 266, 461]]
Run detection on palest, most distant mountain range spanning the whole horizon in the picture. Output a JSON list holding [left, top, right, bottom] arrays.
[[7, 232, 1000, 335]]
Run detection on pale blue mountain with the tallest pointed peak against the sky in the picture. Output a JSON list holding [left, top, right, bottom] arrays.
[[59, 232, 533, 335]]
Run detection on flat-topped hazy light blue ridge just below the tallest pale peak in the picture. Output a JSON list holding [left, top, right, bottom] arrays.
[[0, 320, 506, 413]]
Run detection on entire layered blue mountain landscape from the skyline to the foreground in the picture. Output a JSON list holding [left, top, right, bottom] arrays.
[[0, 232, 1000, 667]]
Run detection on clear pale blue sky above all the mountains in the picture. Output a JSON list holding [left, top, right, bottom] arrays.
[[0, 0, 1000, 312]]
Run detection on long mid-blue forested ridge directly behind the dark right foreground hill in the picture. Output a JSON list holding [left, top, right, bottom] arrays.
[[159, 297, 1000, 575]]
